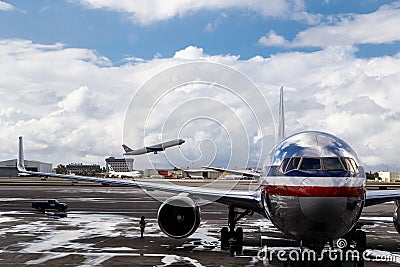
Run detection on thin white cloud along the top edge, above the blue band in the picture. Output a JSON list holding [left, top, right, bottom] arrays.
[[70, 0, 310, 24]]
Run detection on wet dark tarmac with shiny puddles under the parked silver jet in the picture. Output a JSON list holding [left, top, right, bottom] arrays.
[[0, 180, 400, 266]]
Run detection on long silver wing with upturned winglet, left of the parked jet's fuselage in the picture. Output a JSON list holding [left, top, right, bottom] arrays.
[[17, 137, 263, 214]]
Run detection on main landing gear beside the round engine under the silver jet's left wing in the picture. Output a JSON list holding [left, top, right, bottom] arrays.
[[221, 205, 253, 254]]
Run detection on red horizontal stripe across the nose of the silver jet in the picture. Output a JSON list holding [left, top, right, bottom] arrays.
[[261, 185, 365, 197]]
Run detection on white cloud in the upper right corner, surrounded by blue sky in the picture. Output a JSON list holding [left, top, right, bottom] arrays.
[[259, 2, 400, 47]]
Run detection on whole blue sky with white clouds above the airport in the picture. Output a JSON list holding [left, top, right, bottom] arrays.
[[0, 0, 400, 171]]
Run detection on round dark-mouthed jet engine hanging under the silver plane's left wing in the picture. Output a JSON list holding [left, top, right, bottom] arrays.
[[158, 196, 200, 238]]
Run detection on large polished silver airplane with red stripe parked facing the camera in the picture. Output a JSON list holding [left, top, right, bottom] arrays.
[[17, 88, 400, 251]]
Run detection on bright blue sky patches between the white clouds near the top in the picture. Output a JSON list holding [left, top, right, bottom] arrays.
[[0, 0, 400, 64]]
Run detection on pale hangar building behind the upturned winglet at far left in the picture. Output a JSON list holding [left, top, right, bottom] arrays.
[[0, 159, 53, 177]]
